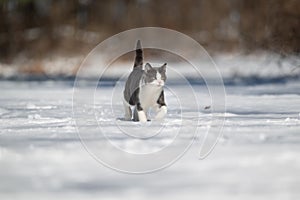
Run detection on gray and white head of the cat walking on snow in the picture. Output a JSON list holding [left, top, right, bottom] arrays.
[[144, 63, 167, 86]]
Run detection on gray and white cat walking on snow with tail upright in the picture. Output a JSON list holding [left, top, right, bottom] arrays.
[[123, 40, 167, 122]]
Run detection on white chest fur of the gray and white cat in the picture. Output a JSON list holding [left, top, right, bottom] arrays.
[[139, 84, 163, 109]]
